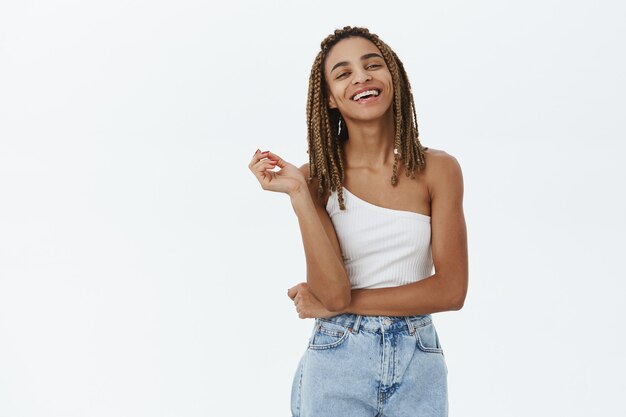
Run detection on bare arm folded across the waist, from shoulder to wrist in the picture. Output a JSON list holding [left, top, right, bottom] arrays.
[[335, 151, 468, 316]]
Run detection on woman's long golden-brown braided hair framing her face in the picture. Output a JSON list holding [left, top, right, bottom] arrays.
[[306, 26, 428, 210]]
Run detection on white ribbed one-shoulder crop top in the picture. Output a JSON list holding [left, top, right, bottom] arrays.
[[326, 187, 433, 288]]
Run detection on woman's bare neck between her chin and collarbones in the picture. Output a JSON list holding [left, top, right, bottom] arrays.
[[344, 108, 395, 170]]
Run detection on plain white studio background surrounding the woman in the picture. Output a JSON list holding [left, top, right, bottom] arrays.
[[0, 0, 626, 417]]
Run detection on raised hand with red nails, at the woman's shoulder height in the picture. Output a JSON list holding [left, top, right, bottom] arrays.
[[248, 149, 307, 195]]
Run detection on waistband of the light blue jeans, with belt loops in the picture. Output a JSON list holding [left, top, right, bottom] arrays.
[[315, 313, 432, 334]]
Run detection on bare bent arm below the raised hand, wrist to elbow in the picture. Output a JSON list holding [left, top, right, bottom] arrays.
[[289, 163, 351, 311]]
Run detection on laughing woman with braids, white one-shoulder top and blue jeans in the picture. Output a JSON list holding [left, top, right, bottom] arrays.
[[249, 26, 468, 417]]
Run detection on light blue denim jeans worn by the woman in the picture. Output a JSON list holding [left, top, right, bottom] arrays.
[[291, 313, 448, 417]]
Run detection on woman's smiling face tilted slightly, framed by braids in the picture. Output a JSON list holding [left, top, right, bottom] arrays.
[[324, 36, 393, 121]]
